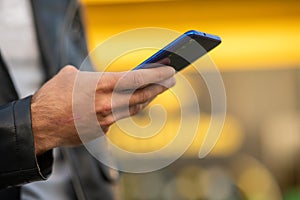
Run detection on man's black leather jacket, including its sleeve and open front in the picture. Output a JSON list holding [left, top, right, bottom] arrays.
[[0, 0, 115, 200]]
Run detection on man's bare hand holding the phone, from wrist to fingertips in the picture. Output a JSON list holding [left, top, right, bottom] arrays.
[[31, 66, 175, 155]]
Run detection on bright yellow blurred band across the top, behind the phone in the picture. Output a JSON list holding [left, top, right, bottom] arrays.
[[82, 0, 300, 70]]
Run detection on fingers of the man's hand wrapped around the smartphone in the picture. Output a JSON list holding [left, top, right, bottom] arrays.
[[95, 65, 176, 128]]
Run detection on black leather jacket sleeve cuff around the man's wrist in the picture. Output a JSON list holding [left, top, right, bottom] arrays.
[[0, 96, 53, 188]]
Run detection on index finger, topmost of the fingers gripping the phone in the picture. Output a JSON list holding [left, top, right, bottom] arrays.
[[98, 66, 175, 91]]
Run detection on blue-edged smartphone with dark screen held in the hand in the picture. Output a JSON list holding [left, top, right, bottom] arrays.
[[133, 30, 221, 71]]
